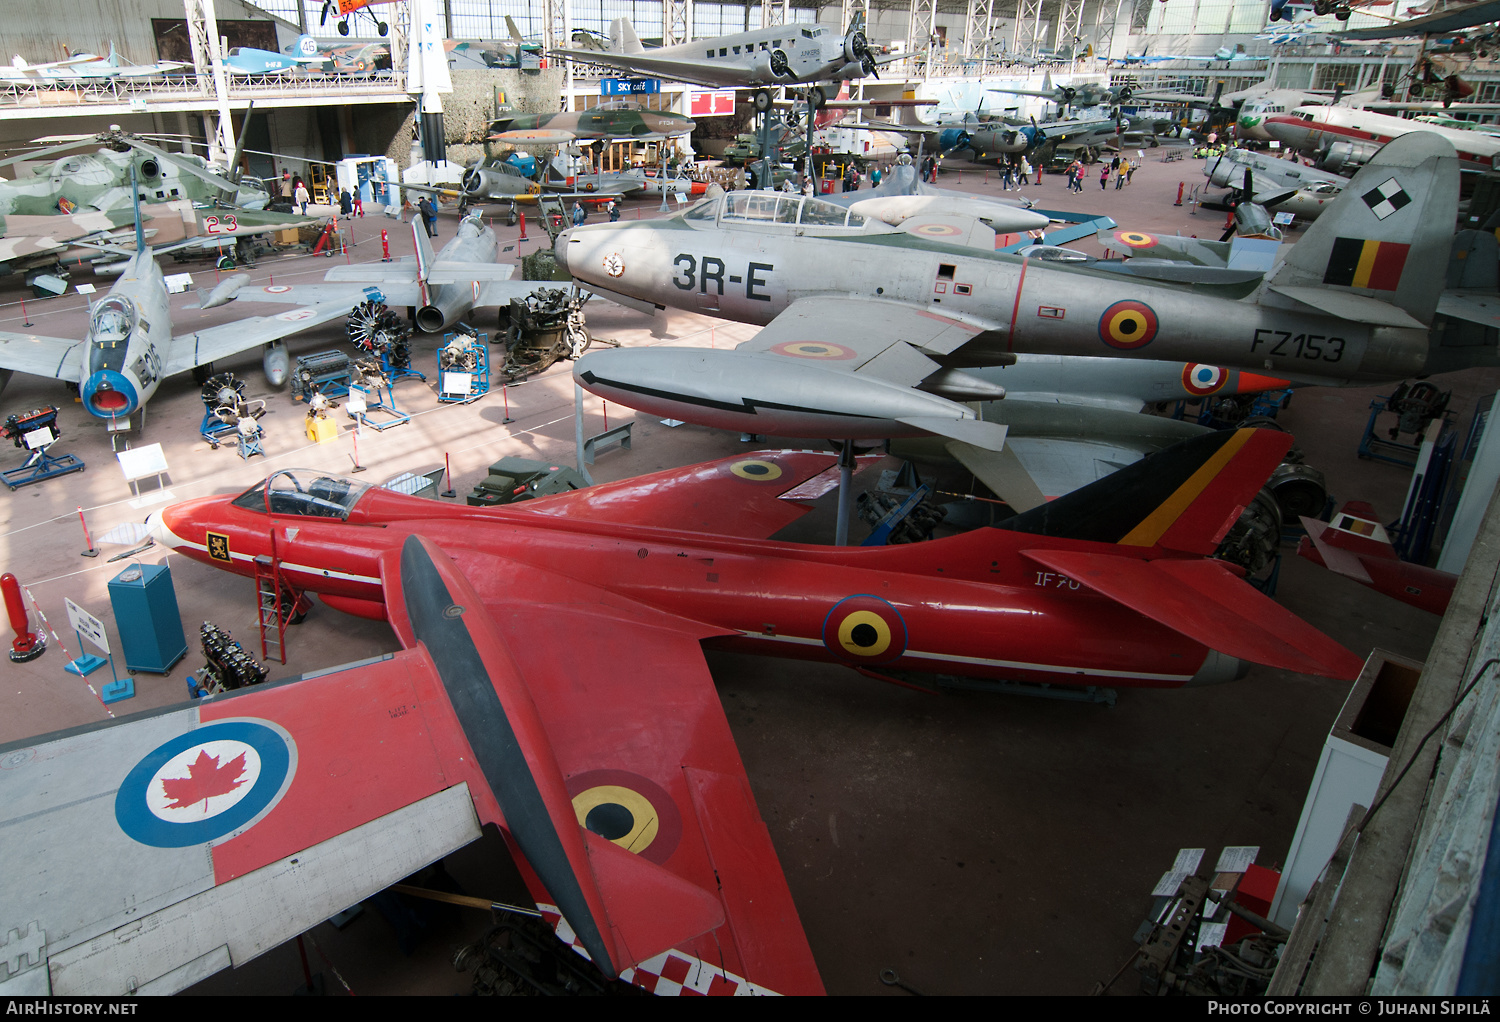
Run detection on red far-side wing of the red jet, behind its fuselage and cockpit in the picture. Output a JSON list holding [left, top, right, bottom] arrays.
[[527, 450, 879, 539]]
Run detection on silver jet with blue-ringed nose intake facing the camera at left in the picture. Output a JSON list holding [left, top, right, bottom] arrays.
[[0, 208, 342, 431]]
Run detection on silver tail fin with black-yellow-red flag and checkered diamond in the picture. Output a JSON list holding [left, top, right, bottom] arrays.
[[1266, 132, 1458, 324]]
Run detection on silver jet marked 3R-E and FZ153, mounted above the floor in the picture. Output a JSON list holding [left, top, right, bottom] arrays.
[[557, 132, 1500, 450]]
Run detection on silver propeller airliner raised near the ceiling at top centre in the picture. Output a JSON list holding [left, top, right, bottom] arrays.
[[552, 14, 906, 113]]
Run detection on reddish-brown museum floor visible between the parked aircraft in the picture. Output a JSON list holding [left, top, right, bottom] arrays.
[[0, 150, 1476, 993]]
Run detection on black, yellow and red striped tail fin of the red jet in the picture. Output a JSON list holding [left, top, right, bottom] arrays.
[[1001, 429, 1292, 555]]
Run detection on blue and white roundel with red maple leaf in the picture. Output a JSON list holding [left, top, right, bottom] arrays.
[[114, 719, 297, 848]]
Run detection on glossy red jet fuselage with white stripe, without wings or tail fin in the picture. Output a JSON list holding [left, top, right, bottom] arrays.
[[153, 477, 1241, 687]]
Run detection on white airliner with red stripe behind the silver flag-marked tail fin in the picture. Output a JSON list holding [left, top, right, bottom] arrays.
[[1262, 107, 1500, 174]]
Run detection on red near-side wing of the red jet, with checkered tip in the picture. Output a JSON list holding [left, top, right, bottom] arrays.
[[435, 549, 822, 995]]
